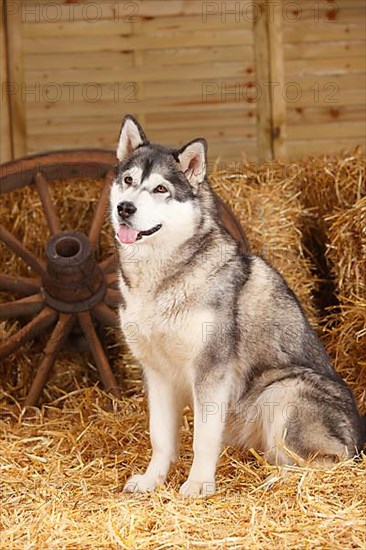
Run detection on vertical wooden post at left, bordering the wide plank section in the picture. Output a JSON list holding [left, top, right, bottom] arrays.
[[4, 0, 27, 158]]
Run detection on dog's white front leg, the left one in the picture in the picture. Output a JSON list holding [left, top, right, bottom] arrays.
[[124, 371, 184, 493]]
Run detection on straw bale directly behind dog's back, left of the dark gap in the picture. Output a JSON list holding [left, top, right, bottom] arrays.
[[211, 161, 317, 324]]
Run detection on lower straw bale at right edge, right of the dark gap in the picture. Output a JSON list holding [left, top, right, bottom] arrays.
[[325, 197, 366, 413]]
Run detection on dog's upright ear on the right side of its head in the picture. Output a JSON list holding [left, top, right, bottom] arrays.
[[178, 138, 207, 189]]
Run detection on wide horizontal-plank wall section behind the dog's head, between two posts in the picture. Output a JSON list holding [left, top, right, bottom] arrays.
[[10, 0, 257, 164]]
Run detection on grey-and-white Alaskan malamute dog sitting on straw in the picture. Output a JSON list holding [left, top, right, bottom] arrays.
[[111, 116, 362, 495]]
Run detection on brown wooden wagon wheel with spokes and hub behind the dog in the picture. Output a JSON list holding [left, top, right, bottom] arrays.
[[0, 149, 249, 406]]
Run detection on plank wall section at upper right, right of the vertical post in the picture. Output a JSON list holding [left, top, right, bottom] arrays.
[[283, 0, 366, 156]]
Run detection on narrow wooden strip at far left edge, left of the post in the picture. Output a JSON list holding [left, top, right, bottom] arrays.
[[0, 0, 12, 163]]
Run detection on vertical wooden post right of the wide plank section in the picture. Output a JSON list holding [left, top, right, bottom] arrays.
[[254, 0, 286, 162]]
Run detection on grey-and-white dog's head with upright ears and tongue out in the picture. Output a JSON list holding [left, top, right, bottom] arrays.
[[111, 115, 207, 250]]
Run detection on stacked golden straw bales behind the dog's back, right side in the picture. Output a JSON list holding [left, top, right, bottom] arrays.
[[213, 153, 366, 412]]
